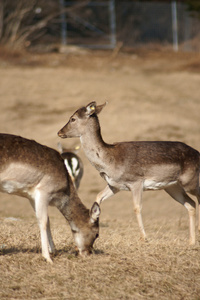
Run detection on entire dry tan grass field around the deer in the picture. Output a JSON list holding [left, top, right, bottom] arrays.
[[0, 50, 200, 300]]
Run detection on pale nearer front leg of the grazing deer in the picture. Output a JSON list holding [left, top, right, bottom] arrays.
[[35, 191, 53, 263]]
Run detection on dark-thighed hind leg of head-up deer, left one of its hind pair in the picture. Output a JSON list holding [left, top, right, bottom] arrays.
[[165, 185, 196, 245]]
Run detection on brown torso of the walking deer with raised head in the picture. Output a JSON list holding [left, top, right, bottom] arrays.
[[82, 138, 199, 191]]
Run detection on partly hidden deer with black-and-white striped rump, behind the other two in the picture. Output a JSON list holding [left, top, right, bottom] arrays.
[[58, 143, 83, 190]]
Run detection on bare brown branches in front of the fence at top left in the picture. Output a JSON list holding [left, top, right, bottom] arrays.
[[0, 0, 88, 49]]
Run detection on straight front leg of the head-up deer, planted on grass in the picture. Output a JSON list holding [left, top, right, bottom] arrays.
[[131, 183, 146, 240]]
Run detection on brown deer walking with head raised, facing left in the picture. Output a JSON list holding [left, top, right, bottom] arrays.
[[58, 101, 200, 245]]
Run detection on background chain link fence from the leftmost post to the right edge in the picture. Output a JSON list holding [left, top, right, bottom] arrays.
[[60, 0, 200, 51]]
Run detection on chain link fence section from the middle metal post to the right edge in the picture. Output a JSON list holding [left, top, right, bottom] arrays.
[[116, 1, 200, 51]]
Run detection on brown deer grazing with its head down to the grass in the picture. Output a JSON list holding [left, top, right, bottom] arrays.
[[0, 133, 100, 264]]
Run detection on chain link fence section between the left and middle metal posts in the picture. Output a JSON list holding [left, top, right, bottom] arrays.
[[60, 0, 116, 48]]
